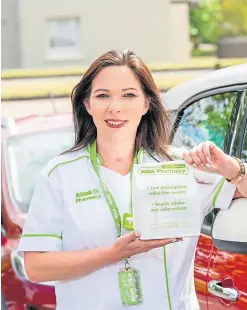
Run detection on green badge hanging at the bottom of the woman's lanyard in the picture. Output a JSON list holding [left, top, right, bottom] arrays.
[[118, 268, 142, 306]]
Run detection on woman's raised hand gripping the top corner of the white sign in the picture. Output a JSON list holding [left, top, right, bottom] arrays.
[[183, 141, 234, 175]]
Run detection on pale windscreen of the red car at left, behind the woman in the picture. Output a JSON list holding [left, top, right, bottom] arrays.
[[6, 128, 74, 213]]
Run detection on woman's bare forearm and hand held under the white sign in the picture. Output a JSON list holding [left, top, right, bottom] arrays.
[[24, 232, 179, 282]]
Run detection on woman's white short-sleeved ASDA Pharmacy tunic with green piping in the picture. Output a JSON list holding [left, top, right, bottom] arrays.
[[18, 149, 236, 310]]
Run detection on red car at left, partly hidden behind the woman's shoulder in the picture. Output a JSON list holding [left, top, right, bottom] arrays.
[[1, 114, 73, 310]]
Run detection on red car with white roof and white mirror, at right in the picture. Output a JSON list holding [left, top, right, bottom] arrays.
[[163, 64, 247, 310]]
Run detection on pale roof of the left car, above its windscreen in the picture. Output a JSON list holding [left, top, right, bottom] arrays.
[[3, 113, 72, 136]]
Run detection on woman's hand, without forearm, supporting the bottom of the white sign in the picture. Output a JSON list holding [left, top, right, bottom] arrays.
[[111, 232, 183, 261]]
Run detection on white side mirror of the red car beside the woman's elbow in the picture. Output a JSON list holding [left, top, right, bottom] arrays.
[[212, 198, 247, 254]]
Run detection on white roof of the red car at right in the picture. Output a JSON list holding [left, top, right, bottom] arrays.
[[163, 63, 247, 110]]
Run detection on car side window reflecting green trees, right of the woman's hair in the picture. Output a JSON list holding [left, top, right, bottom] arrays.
[[173, 92, 237, 149]]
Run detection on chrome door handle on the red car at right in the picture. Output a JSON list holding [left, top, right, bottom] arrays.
[[208, 280, 238, 301]]
